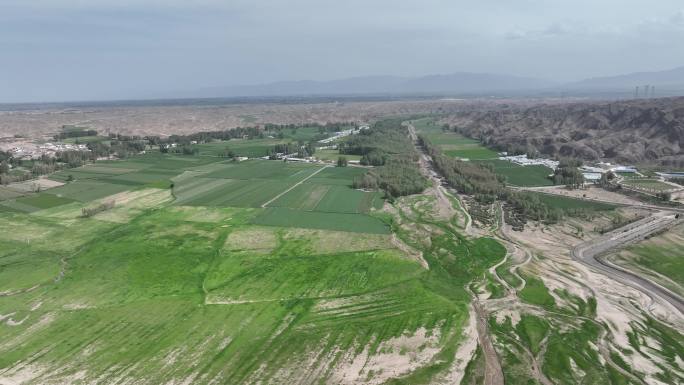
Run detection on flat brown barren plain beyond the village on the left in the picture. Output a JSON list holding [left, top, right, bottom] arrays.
[[0, 100, 503, 141]]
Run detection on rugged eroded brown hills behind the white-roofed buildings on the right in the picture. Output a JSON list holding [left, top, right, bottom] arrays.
[[446, 97, 684, 167]]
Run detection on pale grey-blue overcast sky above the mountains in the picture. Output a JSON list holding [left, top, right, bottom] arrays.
[[0, 0, 684, 102]]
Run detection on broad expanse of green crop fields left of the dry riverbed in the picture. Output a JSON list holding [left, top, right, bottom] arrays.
[[0, 143, 510, 384]]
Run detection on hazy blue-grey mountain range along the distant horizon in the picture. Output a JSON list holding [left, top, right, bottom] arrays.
[[175, 67, 684, 98]]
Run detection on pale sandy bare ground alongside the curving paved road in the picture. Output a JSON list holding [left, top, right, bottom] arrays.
[[500, 214, 684, 383]]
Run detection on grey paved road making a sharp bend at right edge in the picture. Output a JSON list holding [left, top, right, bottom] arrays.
[[572, 211, 684, 314]]
